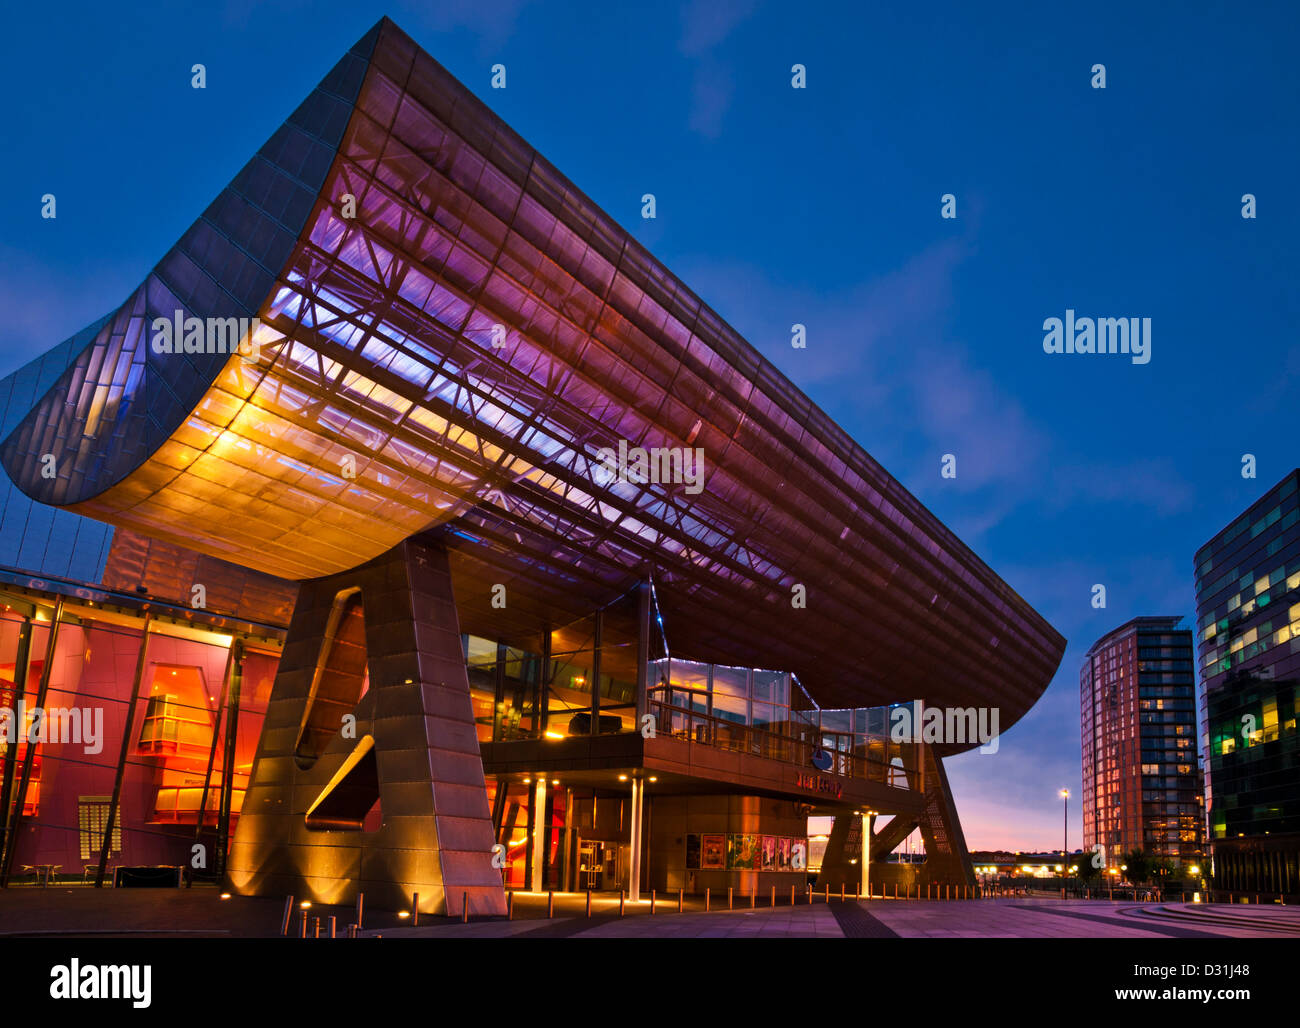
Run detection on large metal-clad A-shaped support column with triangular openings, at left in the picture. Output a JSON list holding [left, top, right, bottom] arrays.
[[228, 539, 506, 916]]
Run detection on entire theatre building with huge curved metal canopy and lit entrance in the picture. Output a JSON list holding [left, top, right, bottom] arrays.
[[0, 19, 1065, 915]]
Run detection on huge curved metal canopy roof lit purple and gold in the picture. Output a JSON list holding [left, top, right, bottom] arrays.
[[0, 19, 1065, 730]]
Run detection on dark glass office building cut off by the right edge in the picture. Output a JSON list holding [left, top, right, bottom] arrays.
[[1196, 470, 1300, 902]]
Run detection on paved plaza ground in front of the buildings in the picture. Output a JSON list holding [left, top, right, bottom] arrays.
[[0, 888, 1300, 938]]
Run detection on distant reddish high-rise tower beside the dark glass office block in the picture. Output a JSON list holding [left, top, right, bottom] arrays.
[[1079, 617, 1203, 866]]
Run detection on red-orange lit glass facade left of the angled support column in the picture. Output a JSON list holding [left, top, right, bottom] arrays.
[[0, 585, 280, 881]]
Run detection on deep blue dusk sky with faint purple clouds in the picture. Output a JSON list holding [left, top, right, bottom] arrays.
[[0, 0, 1300, 849]]
